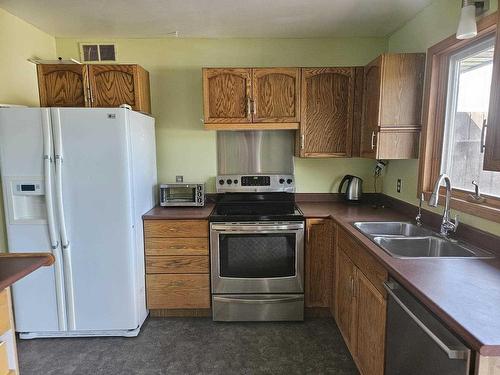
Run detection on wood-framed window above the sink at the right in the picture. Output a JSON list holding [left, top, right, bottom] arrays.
[[419, 13, 500, 222]]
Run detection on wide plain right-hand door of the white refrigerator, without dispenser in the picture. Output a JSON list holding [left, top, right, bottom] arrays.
[[52, 108, 139, 331]]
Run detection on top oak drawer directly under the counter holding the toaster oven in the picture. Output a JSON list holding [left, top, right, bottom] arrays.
[[144, 220, 208, 238]]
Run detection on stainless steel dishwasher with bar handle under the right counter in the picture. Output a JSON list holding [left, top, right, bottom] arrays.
[[384, 279, 471, 375]]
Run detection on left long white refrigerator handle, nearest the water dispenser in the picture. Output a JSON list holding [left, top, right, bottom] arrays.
[[42, 109, 67, 331]]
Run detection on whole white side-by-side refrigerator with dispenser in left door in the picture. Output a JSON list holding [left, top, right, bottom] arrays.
[[0, 108, 157, 338]]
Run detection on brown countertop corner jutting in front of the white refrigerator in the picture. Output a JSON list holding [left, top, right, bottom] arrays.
[[0, 253, 54, 290]]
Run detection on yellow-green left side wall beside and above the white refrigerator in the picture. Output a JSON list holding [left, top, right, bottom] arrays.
[[0, 8, 56, 251]]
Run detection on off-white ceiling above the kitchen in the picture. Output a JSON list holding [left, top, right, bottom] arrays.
[[0, 0, 436, 38]]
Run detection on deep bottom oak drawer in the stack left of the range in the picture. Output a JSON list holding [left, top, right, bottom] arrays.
[[146, 274, 210, 309]]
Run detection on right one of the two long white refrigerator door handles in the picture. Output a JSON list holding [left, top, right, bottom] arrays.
[[51, 108, 76, 330]]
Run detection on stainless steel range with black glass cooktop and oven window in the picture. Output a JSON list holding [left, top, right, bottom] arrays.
[[210, 174, 304, 321]]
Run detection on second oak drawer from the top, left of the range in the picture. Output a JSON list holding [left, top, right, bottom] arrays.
[[145, 237, 208, 255]]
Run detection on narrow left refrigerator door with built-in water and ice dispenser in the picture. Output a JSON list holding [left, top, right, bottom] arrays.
[[0, 108, 65, 332]]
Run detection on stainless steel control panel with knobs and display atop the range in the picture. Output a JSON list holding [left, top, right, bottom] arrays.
[[216, 174, 295, 193]]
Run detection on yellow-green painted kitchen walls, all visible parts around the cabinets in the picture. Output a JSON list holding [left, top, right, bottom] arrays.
[[4, 0, 500, 248]]
